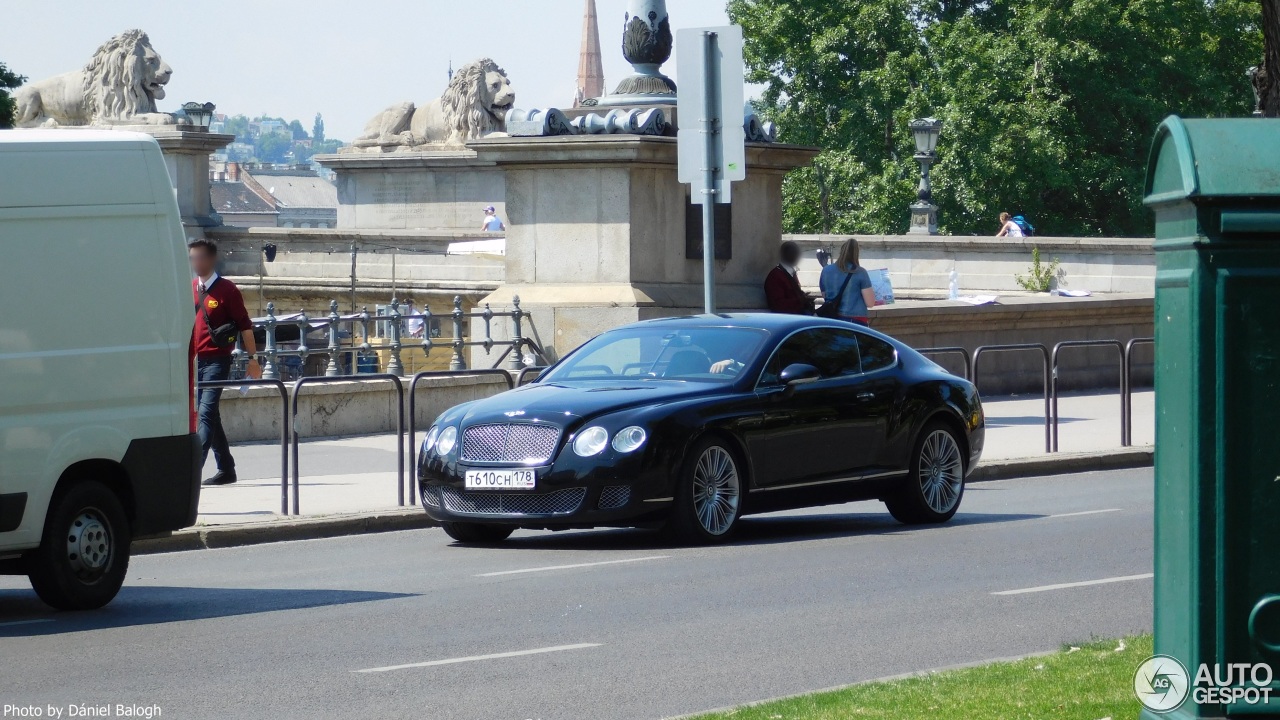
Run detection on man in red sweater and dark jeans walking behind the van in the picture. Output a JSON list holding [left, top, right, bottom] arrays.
[[187, 240, 262, 486]]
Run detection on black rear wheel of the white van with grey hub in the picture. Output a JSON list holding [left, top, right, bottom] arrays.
[[27, 480, 133, 610]]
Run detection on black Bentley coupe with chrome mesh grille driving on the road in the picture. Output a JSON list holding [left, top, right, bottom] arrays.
[[417, 314, 984, 543]]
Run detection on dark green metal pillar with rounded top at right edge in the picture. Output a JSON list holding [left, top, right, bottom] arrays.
[[1142, 117, 1280, 720]]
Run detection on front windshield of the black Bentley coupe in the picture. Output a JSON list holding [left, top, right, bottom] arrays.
[[543, 327, 767, 383]]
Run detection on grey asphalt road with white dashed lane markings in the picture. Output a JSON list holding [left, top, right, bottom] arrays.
[[0, 469, 1152, 720]]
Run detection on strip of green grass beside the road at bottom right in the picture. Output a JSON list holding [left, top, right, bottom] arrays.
[[696, 635, 1152, 720]]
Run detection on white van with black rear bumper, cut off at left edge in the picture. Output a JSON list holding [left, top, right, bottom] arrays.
[[0, 129, 200, 610]]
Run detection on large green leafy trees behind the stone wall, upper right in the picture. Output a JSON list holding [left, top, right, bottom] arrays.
[[728, 0, 1262, 236]]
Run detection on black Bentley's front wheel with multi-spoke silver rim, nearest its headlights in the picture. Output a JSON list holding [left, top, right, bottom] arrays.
[[667, 438, 746, 544]]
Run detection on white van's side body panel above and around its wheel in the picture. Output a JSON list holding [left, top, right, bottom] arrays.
[[0, 142, 198, 551]]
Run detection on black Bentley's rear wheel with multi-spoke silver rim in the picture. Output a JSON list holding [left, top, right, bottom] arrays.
[[884, 423, 965, 525]]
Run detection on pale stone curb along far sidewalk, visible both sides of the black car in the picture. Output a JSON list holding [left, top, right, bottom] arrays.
[[133, 446, 1155, 555]]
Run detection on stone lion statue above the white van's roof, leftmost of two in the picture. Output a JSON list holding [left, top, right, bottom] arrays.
[[14, 29, 178, 128]]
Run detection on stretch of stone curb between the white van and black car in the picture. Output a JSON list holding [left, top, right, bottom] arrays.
[[132, 507, 439, 555]]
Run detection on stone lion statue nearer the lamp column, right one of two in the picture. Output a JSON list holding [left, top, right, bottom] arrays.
[[352, 58, 516, 150]]
